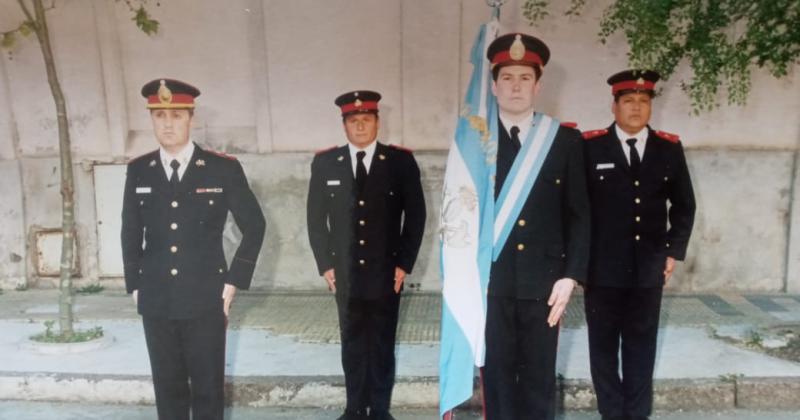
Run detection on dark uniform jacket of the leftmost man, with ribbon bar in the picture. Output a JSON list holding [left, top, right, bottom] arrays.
[[122, 145, 265, 319]]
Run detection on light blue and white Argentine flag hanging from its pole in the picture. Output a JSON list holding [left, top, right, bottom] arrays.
[[439, 17, 499, 419]]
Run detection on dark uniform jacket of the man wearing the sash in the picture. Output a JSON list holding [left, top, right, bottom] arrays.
[[489, 123, 590, 299]]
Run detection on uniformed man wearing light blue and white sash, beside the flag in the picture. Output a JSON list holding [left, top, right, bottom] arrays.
[[483, 33, 590, 420]]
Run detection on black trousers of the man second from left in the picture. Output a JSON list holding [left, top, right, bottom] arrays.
[[337, 293, 400, 412]]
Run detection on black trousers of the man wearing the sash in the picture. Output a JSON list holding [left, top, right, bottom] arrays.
[[483, 296, 559, 420]]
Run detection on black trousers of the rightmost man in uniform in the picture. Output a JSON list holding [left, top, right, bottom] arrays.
[[584, 287, 662, 417]]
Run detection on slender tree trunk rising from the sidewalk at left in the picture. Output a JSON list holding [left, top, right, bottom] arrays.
[[24, 0, 75, 337]]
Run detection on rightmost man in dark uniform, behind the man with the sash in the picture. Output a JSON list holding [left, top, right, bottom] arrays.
[[584, 70, 695, 420]]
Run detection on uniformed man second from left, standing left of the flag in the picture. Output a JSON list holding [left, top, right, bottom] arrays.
[[308, 90, 425, 420]]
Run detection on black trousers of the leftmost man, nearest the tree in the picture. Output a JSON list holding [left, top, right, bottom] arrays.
[[142, 312, 226, 420]]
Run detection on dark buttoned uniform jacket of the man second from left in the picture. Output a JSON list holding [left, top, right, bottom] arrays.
[[307, 143, 425, 298]]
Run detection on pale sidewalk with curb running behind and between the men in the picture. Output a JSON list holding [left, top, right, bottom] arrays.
[[0, 290, 800, 410]]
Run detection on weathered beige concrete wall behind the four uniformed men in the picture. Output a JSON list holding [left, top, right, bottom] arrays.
[[0, 0, 800, 292]]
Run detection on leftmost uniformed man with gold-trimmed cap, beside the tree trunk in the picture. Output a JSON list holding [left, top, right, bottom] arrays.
[[122, 79, 264, 420]]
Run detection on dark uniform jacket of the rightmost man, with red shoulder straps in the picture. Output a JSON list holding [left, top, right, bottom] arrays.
[[584, 124, 695, 287]]
